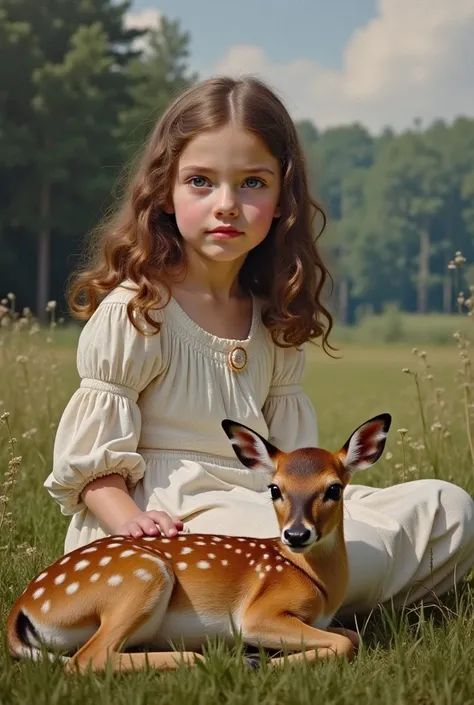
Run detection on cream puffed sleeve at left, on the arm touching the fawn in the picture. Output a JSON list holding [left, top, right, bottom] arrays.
[[44, 299, 163, 515]]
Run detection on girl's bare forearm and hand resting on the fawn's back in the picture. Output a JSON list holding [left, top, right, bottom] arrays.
[[82, 474, 183, 538]]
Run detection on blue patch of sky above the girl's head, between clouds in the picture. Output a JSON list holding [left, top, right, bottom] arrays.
[[132, 0, 376, 71]]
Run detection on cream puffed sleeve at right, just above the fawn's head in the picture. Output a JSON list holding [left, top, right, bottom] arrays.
[[262, 347, 318, 452]]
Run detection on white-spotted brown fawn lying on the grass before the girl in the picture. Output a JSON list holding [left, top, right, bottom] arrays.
[[7, 414, 391, 670]]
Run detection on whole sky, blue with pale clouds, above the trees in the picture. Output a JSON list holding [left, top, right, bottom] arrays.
[[127, 0, 474, 133]]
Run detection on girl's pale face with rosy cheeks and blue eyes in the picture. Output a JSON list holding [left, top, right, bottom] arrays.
[[167, 125, 281, 262]]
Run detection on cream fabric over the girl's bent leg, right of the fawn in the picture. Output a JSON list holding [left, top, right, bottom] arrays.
[[341, 480, 474, 614]]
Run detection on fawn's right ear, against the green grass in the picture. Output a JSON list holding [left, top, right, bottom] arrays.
[[337, 414, 392, 475]]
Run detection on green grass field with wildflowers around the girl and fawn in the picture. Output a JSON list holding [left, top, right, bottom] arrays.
[[0, 320, 474, 705]]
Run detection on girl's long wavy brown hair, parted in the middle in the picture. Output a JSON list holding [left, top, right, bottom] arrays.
[[68, 76, 333, 352]]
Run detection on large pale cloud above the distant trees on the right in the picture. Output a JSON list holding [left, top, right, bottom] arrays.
[[212, 0, 474, 131]]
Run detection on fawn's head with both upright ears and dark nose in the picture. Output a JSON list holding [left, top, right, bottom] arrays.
[[222, 414, 391, 553]]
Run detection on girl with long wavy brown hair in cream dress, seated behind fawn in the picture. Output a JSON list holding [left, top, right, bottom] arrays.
[[45, 77, 474, 612]]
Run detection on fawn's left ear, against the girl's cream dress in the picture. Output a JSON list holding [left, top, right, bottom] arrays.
[[222, 419, 281, 473]]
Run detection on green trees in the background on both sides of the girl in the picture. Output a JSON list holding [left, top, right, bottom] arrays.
[[0, 0, 474, 322]]
